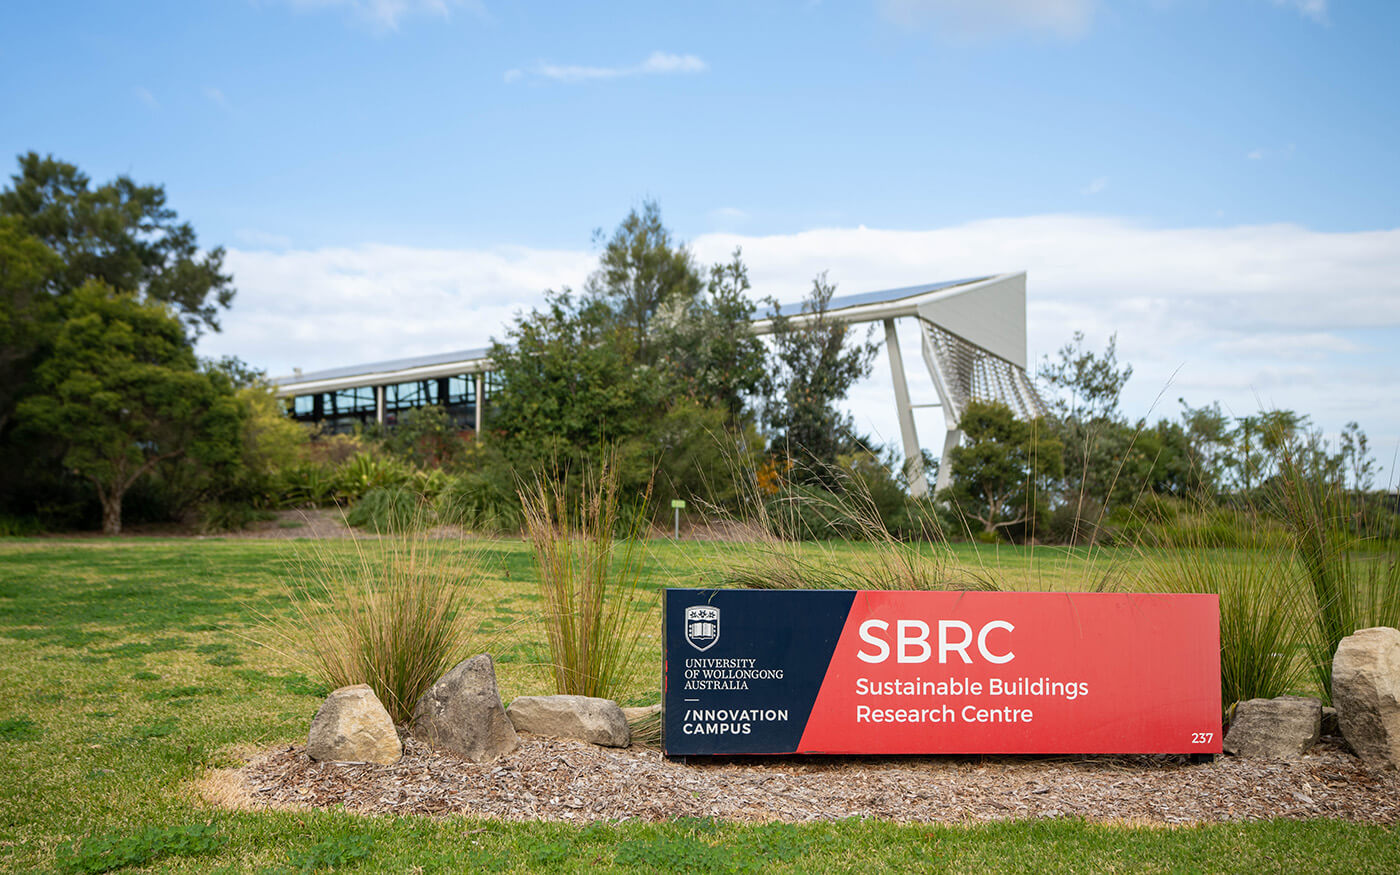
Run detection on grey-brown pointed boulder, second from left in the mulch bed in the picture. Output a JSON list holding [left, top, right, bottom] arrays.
[[410, 654, 519, 763]]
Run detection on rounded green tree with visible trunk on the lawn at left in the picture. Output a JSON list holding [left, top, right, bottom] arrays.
[[17, 280, 241, 535]]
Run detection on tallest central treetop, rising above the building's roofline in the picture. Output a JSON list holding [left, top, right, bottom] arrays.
[[585, 200, 701, 364]]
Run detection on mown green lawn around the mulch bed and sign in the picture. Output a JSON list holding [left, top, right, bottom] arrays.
[[0, 539, 1400, 872]]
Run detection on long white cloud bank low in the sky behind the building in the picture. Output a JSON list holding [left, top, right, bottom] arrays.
[[202, 216, 1400, 456]]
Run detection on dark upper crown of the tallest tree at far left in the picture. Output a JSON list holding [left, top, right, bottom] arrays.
[[0, 151, 234, 337]]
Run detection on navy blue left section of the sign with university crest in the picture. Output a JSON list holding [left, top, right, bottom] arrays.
[[665, 589, 855, 756]]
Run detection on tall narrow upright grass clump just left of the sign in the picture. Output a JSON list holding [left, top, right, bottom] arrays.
[[519, 456, 651, 699]]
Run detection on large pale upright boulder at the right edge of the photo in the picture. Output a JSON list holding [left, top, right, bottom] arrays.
[[1331, 626, 1400, 769]]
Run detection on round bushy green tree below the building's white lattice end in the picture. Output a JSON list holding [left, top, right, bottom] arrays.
[[938, 400, 1064, 535]]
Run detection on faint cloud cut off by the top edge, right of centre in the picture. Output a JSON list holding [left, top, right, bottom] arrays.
[[879, 0, 1098, 38]]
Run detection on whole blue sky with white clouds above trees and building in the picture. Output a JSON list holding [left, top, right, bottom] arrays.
[[0, 0, 1400, 468]]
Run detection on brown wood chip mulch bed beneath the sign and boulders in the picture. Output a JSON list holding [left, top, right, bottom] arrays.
[[215, 735, 1400, 825]]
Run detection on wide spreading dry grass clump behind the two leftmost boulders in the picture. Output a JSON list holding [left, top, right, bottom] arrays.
[[274, 518, 482, 724]]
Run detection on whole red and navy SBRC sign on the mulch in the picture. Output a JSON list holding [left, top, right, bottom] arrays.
[[665, 589, 1222, 756]]
